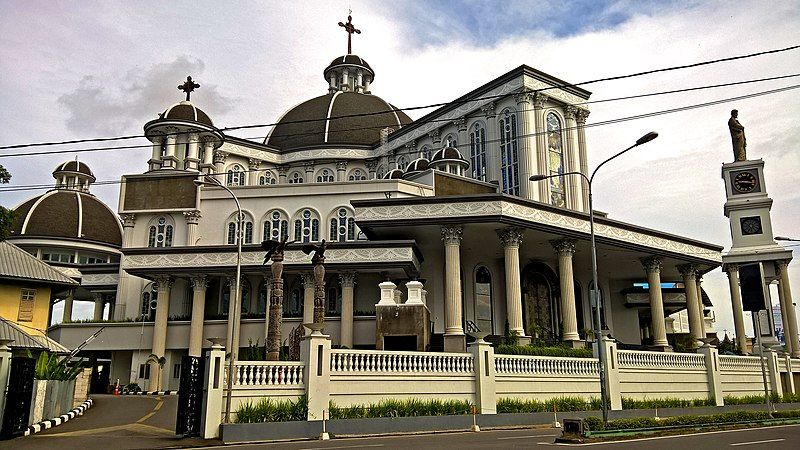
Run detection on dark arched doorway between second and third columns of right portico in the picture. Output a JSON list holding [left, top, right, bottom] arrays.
[[522, 262, 560, 342]]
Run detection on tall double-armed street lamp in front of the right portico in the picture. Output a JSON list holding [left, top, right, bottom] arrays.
[[529, 131, 658, 423]]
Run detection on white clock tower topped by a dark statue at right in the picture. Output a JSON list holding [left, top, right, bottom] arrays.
[[722, 110, 800, 356]]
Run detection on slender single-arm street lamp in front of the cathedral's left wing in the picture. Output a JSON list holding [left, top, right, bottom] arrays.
[[194, 176, 244, 423]]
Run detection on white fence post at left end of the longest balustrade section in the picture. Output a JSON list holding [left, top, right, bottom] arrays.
[[300, 324, 331, 420]]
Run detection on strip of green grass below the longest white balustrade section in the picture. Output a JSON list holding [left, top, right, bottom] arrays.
[[328, 399, 473, 419]]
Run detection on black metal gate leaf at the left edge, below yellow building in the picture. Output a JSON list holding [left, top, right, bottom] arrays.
[[0, 357, 36, 439]]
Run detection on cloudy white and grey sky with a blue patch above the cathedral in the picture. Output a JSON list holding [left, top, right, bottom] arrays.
[[0, 0, 800, 330]]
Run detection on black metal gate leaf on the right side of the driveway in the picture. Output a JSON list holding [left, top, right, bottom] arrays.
[[175, 355, 205, 436]]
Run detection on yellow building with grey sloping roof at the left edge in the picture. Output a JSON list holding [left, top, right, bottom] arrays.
[[0, 242, 78, 335]]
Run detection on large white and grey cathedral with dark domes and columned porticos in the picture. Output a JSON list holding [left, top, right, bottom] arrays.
[[37, 20, 722, 389]]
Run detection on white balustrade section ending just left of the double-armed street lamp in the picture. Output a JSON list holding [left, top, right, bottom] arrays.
[[494, 355, 600, 376]]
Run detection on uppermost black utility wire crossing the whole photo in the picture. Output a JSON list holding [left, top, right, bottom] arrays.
[[0, 45, 800, 150]]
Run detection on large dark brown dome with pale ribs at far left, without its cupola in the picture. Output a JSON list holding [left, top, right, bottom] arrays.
[[10, 189, 122, 248]]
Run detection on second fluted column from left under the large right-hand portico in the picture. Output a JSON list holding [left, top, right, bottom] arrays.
[[497, 228, 530, 345]]
